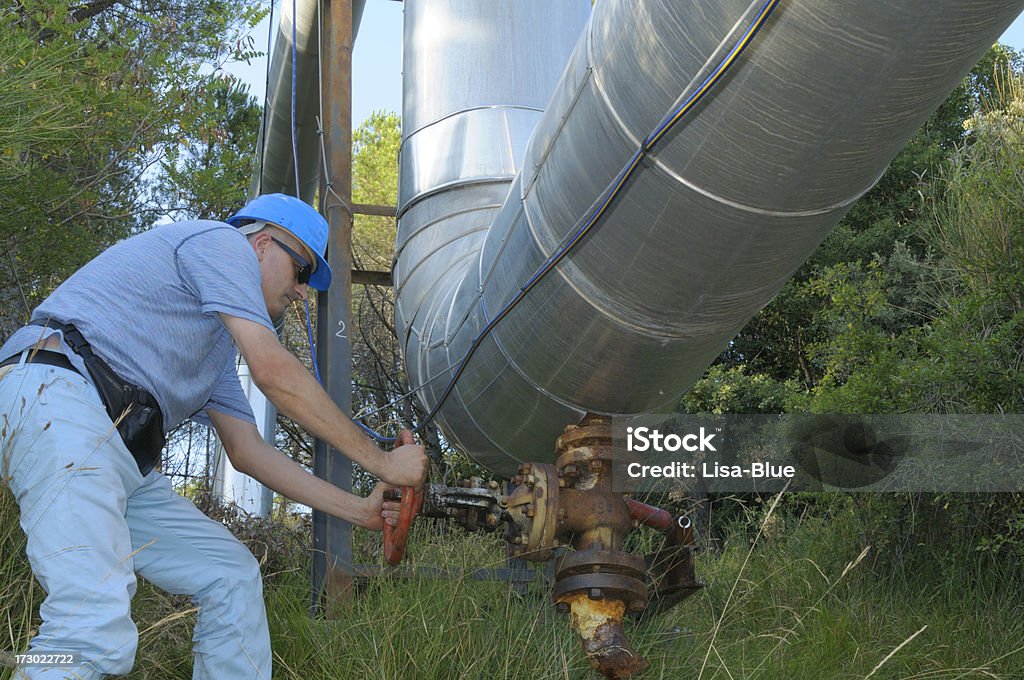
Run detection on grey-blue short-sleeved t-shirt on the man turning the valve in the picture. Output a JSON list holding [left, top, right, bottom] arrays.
[[0, 220, 273, 430]]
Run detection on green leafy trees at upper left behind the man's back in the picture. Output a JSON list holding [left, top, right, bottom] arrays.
[[0, 0, 260, 334]]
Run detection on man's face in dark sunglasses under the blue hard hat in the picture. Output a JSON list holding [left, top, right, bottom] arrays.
[[253, 229, 313, 322]]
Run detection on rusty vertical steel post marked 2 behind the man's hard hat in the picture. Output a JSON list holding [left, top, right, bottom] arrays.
[[312, 0, 352, 612]]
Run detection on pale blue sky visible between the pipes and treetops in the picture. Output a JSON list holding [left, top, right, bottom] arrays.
[[226, 0, 1024, 130]]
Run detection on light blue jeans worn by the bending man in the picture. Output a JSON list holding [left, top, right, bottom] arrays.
[[0, 357, 270, 680]]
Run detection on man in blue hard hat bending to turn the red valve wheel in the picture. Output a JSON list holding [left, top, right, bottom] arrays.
[[0, 195, 427, 680]]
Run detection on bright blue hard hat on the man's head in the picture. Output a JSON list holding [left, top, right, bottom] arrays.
[[225, 194, 331, 291]]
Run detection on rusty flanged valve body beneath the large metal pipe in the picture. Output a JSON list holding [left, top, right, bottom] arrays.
[[403, 415, 700, 678]]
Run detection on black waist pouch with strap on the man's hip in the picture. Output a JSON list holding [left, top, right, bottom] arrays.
[[38, 322, 166, 475]]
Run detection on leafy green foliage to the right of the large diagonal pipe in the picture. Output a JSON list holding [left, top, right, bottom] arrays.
[[680, 46, 1024, 573]]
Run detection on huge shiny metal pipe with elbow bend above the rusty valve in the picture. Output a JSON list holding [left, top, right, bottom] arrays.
[[394, 0, 1024, 471]]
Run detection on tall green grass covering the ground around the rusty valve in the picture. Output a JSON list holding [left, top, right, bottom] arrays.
[[0, 491, 1024, 680]]
